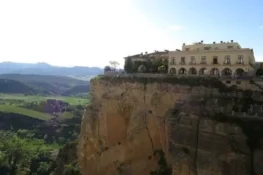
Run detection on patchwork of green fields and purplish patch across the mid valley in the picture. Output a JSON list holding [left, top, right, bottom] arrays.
[[0, 94, 89, 120]]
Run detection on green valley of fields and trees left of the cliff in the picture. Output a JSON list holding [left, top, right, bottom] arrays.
[[0, 77, 89, 175]]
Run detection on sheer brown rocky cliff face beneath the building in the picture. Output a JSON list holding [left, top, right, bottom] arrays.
[[78, 77, 263, 175]]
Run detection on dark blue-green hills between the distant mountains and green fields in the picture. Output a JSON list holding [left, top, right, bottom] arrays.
[[0, 74, 89, 96]]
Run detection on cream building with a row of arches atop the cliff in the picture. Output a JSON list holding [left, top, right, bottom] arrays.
[[168, 40, 255, 77]]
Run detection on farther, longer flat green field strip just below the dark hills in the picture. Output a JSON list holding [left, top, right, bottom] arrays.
[[0, 94, 89, 105]]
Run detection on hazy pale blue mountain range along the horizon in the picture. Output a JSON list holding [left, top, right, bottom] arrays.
[[0, 62, 103, 79]]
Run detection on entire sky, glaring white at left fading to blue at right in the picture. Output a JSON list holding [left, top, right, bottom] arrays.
[[0, 0, 263, 67]]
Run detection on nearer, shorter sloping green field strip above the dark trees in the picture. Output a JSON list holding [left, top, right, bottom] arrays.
[[0, 105, 52, 120]]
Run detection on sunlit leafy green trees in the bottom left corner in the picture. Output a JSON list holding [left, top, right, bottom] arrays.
[[0, 131, 79, 175]]
